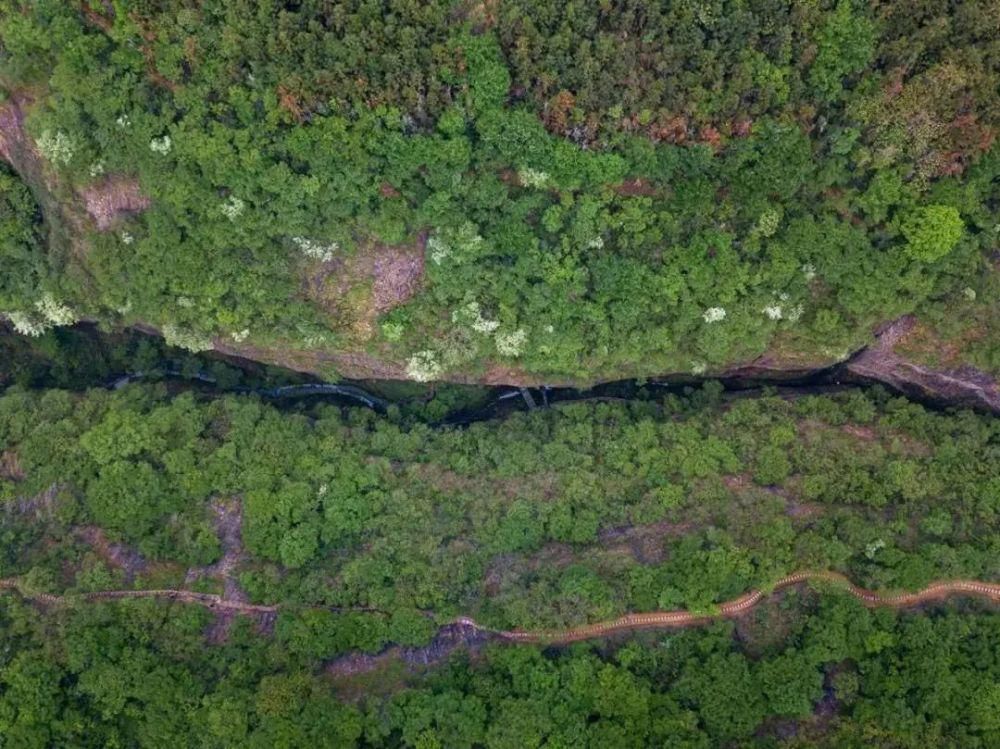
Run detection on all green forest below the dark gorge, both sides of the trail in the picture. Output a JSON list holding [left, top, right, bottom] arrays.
[[0, 376, 1000, 747]]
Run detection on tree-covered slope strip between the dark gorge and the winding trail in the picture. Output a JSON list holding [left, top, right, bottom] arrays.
[[0, 385, 1000, 624]]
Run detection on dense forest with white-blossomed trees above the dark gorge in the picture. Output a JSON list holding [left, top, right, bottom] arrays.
[[0, 0, 1000, 379]]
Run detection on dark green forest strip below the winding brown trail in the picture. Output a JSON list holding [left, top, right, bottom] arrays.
[[0, 596, 1000, 749]]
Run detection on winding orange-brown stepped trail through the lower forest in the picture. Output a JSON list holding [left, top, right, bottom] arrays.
[[0, 572, 1000, 645]]
